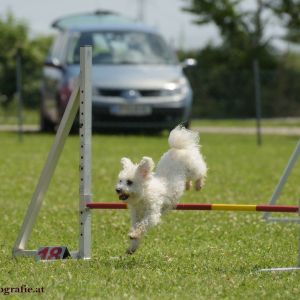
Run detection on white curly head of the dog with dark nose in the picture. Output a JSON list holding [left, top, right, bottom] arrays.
[[116, 157, 154, 201]]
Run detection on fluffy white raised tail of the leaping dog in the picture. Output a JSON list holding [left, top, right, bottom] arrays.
[[168, 125, 199, 149]]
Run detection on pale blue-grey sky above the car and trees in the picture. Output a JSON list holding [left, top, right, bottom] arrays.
[[0, 0, 286, 50]]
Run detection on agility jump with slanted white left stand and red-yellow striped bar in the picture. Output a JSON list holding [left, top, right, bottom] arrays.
[[13, 46, 300, 270]]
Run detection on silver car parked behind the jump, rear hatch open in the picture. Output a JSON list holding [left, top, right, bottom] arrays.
[[40, 12, 195, 130]]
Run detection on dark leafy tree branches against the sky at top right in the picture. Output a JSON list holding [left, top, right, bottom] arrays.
[[184, 0, 300, 62]]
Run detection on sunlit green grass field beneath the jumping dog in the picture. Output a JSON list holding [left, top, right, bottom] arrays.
[[0, 133, 300, 299]]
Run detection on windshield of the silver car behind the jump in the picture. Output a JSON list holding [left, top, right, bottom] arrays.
[[67, 31, 177, 65]]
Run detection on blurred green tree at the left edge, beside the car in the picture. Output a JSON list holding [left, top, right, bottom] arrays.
[[0, 13, 52, 105]]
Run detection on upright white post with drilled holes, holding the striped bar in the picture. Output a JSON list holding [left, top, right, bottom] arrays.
[[78, 46, 92, 259]]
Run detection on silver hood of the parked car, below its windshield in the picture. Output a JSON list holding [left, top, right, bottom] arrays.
[[69, 65, 183, 89]]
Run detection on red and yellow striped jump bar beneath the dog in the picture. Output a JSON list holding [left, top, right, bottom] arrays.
[[86, 202, 299, 213]]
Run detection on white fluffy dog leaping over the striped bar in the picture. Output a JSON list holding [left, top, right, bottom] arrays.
[[116, 126, 207, 254]]
